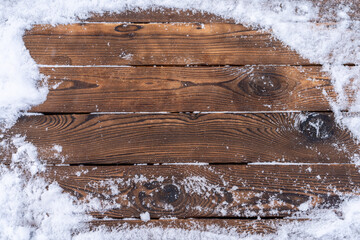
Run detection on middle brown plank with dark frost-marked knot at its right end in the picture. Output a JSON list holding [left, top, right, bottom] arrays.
[[3, 113, 358, 164]]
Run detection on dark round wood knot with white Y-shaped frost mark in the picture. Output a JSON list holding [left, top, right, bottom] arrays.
[[300, 114, 334, 141]]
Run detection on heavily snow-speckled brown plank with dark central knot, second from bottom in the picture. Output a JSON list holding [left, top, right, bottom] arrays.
[[46, 164, 360, 219]]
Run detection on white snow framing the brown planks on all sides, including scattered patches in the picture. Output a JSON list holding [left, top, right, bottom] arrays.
[[0, 0, 360, 239]]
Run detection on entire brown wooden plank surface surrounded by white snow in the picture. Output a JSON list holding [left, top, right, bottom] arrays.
[[21, 7, 360, 234]]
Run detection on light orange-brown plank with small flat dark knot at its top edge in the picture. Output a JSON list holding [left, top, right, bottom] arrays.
[[24, 23, 309, 65]]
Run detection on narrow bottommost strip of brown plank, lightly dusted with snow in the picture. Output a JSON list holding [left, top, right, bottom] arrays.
[[90, 218, 298, 235]]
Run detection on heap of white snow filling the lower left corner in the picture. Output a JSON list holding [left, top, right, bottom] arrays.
[[0, 140, 91, 239]]
